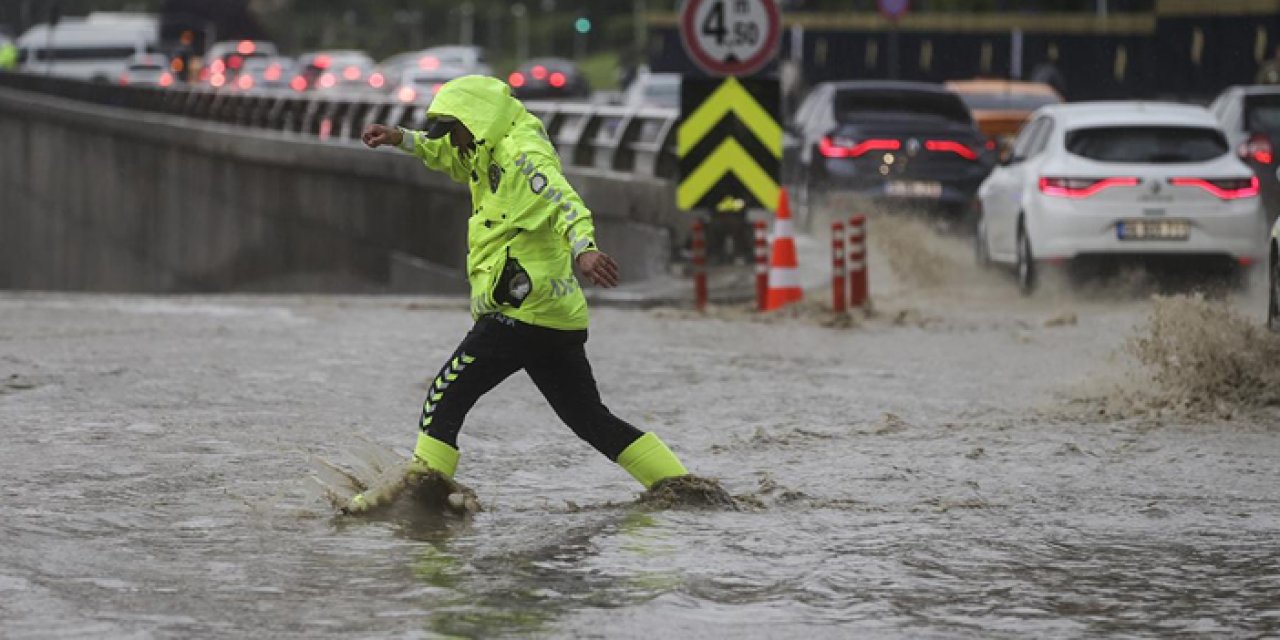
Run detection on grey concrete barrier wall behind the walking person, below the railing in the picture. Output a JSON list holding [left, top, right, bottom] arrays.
[[0, 88, 684, 293]]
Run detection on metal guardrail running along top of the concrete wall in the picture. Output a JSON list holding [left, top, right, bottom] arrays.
[[0, 73, 680, 179]]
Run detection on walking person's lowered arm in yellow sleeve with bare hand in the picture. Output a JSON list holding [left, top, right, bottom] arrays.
[[515, 154, 618, 287]]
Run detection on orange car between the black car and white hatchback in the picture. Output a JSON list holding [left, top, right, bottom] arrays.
[[945, 78, 1062, 150]]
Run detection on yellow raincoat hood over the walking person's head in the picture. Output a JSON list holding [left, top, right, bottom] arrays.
[[426, 76, 525, 142]]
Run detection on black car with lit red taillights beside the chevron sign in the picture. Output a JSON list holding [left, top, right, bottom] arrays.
[[785, 81, 995, 224]]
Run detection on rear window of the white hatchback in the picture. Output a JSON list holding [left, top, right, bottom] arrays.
[[1066, 127, 1228, 163]]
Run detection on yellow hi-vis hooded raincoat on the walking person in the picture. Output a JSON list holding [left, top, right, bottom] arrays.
[[401, 76, 596, 329]]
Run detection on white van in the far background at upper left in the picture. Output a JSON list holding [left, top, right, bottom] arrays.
[[18, 12, 160, 82]]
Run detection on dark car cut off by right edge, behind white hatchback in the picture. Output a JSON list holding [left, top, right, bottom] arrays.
[[1210, 84, 1280, 225]]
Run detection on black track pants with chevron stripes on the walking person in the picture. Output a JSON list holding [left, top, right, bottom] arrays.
[[419, 315, 644, 461]]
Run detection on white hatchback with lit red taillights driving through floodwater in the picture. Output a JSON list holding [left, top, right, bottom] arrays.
[[975, 101, 1266, 293]]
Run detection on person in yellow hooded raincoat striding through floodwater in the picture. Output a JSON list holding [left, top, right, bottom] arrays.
[[355, 76, 689, 508]]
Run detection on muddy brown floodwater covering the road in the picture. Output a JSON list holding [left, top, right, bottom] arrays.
[[0, 223, 1280, 639]]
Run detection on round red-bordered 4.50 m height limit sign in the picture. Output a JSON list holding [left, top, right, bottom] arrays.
[[680, 0, 782, 76]]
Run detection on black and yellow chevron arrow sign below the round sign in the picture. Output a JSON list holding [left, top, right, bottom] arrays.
[[676, 76, 782, 211]]
